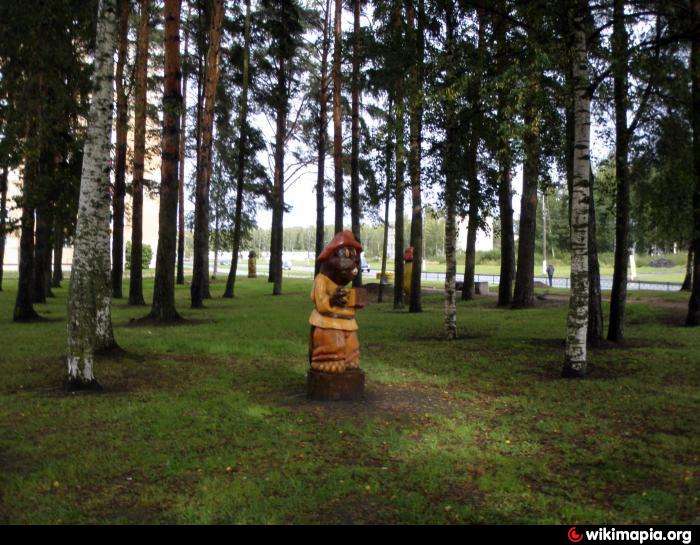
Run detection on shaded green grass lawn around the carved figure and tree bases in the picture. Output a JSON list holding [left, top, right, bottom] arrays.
[[0, 278, 700, 525]]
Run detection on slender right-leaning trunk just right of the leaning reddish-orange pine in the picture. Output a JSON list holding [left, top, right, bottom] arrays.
[[224, 0, 250, 298]]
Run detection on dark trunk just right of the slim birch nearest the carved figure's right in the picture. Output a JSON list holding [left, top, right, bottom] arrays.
[[462, 9, 486, 300]]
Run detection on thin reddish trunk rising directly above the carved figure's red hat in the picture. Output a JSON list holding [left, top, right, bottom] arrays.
[[333, 0, 343, 233]]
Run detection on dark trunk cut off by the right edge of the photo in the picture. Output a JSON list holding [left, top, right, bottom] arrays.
[[685, 0, 700, 326]]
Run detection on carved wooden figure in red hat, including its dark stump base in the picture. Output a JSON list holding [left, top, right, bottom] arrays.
[[308, 231, 367, 399]]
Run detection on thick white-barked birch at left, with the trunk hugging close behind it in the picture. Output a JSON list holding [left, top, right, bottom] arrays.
[[67, 0, 117, 388]]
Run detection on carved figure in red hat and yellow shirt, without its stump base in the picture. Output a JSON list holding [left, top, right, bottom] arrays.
[[309, 231, 367, 373]]
